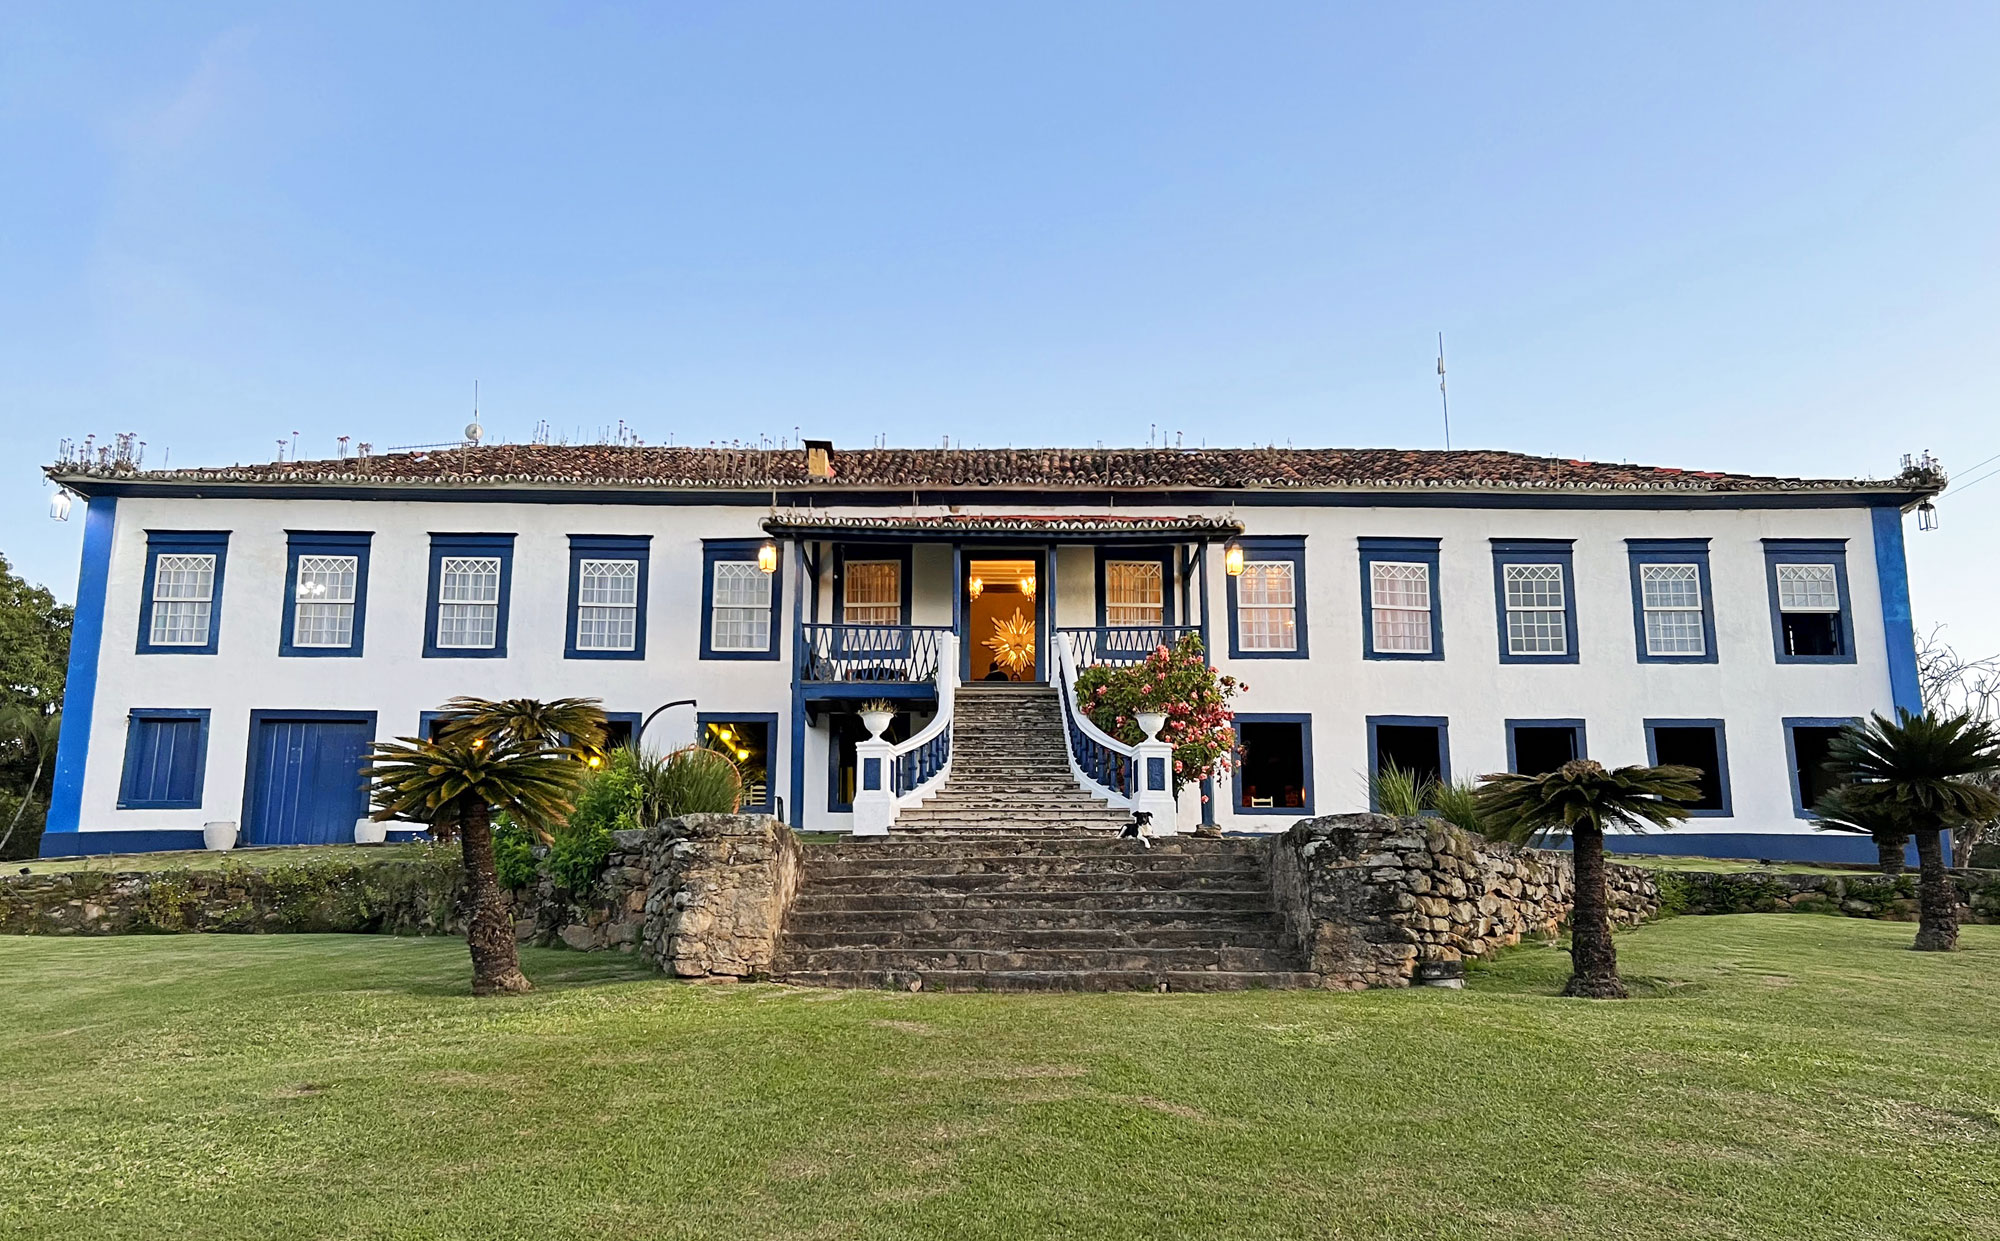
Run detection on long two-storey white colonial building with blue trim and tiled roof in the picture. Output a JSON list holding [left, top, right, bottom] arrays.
[[42, 442, 1936, 859]]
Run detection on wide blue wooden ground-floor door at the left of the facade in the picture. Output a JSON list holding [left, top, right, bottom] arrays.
[[244, 719, 374, 845]]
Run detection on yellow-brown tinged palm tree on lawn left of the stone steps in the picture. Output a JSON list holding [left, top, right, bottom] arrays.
[[364, 729, 588, 995]]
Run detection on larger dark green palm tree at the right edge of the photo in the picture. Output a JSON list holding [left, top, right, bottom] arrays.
[[1826, 709, 2000, 953]]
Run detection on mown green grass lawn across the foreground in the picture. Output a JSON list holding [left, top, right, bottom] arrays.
[[0, 915, 2000, 1241]]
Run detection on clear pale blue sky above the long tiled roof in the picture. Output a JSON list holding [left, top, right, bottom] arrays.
[[0, 0, 2000, 653]]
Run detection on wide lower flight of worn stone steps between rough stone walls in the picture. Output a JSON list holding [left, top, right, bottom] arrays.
[[772, 828, 1318, 991]]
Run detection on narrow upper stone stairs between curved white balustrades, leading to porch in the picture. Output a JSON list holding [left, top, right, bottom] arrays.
[[890, 683, 1132, 837]]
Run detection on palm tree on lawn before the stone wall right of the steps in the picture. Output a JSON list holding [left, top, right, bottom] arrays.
[[1480, 759, 1702, 999]]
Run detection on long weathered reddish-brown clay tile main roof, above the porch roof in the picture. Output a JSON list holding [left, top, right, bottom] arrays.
[[46, 436, 1936, 492]]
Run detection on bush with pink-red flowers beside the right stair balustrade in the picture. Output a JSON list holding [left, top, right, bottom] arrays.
[[1076, 633, 1250, 795]]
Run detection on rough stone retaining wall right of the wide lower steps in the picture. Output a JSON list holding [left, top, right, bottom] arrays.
[[1270, 815, 1660, 989]]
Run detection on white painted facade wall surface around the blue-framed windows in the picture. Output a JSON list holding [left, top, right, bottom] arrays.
[[70, 496, 1890, 833]]
